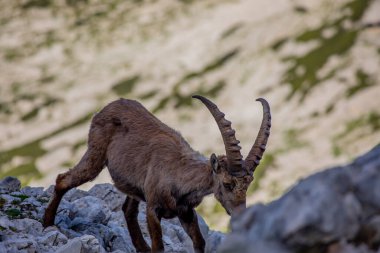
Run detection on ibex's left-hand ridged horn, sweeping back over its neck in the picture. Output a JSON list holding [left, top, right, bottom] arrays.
[[192, 95, 243, 175]]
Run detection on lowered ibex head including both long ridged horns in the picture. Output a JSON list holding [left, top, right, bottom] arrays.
[[193, 95, 271, 214]]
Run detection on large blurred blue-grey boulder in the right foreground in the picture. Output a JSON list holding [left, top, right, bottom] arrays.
[[220, 145, 380, 253]]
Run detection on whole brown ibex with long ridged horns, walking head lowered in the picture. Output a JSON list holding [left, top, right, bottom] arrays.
[[44, 96, 271, 252]]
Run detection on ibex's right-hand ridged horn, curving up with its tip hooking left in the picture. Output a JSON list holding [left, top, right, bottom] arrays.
[[245, 98, 271, 173]]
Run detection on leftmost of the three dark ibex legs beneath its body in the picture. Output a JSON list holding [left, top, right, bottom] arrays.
[[122, 197, 151, 252]]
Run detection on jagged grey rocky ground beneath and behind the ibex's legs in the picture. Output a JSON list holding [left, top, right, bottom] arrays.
[[0, 177, 224, 253]]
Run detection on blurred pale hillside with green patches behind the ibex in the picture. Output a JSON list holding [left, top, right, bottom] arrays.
[[0, 0, 380, 230]]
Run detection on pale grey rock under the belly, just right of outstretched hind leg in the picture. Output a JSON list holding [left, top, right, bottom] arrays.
[[88, 184, 126, 211]]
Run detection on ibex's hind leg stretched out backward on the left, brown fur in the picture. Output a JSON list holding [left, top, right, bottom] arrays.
[[43, 122, 111, 227]]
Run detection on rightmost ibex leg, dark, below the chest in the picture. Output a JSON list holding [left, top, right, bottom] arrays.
[[178, 209, 206, 253]]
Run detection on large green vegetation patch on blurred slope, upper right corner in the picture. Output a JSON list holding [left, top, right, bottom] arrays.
[[280, 0, 371, 101]]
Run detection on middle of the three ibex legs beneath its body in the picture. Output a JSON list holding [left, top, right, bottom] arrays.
[[146, 203, 164, 252]]
